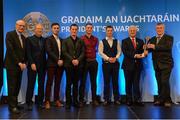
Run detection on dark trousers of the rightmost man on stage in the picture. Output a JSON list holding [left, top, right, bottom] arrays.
[[155, 68, 172, 102]]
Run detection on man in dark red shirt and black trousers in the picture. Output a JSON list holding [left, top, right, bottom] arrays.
[[79, 23, 99, 106]]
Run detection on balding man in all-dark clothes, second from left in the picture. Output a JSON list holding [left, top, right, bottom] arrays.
[[26, 24, 46, 110]]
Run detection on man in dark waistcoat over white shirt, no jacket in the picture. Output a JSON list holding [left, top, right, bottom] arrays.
[[99, 26, 121, 105]]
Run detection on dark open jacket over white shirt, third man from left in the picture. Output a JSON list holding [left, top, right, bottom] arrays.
[[45, 35, 63, 67]]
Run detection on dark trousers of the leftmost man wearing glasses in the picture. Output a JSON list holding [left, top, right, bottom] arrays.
[[7, 67, 22, 108]]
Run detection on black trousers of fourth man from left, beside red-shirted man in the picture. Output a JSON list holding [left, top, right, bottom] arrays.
[[65, 66, 82, 105]]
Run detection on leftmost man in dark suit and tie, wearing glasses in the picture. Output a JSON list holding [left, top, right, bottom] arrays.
[[5, 20, 26, 113]]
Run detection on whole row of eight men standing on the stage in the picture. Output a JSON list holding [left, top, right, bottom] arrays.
[[5, 20, 173, 113]]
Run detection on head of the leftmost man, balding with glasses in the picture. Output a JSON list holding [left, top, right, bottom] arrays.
[[16, 20, 26, 33]]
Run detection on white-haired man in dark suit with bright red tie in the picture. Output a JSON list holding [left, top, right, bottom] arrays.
[[122, 25, 147, 105]]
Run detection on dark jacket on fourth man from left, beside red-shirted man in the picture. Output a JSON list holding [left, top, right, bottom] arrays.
[[62, 37, 85, 67]]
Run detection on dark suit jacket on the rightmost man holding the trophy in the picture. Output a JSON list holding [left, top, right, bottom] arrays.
[[149, 34, 174, 69]]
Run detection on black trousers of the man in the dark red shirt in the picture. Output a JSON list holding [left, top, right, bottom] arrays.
[[79, 60, 98, 102]]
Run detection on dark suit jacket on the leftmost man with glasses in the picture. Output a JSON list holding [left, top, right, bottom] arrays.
[[4, 30, 27, 69]]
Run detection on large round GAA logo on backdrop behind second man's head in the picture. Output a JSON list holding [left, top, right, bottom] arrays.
[[23, 12, 50, 37]]
